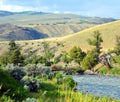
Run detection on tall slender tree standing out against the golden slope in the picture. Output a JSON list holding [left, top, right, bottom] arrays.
[[88, 30, 103, 56]]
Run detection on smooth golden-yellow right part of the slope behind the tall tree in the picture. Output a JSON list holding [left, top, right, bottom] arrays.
[[62, 21, 120, 50]]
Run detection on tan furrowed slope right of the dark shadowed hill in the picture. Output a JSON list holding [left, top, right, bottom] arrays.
[[33, 24, 95, 37]]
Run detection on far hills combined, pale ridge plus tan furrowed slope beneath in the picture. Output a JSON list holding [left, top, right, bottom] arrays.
[[0, 11, 116, 40]]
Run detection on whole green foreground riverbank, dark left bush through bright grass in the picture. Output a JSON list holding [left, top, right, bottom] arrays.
[[0, 66, 120, 102]]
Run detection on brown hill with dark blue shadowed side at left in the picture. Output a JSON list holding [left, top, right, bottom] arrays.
[[0, 24, 47, 41]]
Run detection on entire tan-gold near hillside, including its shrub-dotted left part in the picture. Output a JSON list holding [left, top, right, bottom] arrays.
[[0, 21, 120, 54]]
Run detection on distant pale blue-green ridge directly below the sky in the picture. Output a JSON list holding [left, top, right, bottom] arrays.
[[0, 11, 115, 25]]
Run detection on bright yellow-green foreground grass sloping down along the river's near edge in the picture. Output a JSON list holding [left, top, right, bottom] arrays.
[[27, 79, 120, 102]]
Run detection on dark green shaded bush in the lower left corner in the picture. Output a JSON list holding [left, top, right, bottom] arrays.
[[0, 70, 28, 100]]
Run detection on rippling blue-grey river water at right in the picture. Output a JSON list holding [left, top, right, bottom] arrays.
[[73, 75, 120, 99]]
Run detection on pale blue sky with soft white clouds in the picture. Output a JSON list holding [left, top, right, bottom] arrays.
[[0, 0, 120, 18]]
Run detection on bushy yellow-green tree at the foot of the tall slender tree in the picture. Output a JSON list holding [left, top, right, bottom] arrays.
[[82, 51, 97, 70]]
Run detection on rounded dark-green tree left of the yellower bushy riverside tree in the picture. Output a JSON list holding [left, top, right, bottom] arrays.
[[70, 46, 86, 65]]
